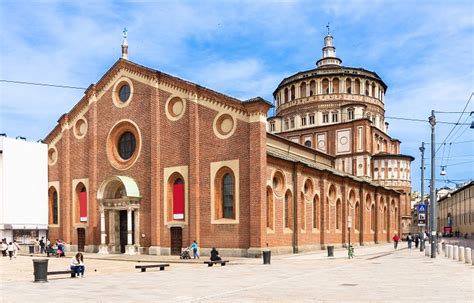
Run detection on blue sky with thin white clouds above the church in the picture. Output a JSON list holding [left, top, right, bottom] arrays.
[[0, 0, 474, 193]]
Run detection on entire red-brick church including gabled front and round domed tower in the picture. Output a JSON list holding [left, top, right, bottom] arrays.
[[45, 32, 413, 257]]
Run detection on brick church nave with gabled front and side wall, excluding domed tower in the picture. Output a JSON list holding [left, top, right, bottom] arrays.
[[45, 32, 403, 256]]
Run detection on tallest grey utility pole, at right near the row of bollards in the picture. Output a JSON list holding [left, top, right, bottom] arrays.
[[429, 110, 438, 258]]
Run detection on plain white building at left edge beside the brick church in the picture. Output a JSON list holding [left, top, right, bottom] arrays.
[[0, 137, 48, 244]]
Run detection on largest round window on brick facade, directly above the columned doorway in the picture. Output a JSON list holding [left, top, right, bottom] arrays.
[[106, 120, 141, 170]]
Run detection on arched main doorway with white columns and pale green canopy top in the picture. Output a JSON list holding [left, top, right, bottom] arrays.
[[97, 176, 141, 255]]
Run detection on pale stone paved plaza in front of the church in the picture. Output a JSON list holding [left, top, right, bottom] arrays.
[[0, 243, 474, 302]]
